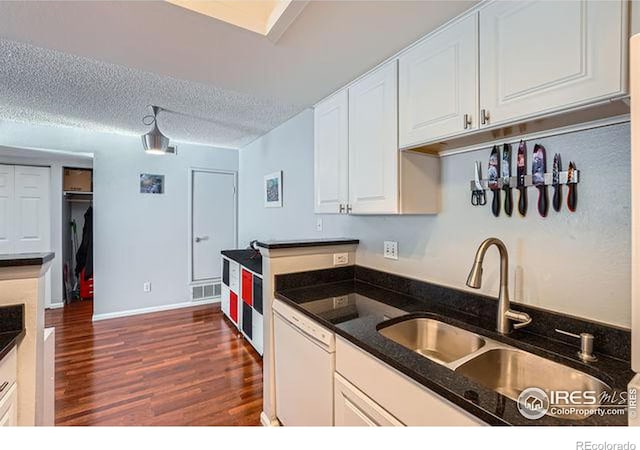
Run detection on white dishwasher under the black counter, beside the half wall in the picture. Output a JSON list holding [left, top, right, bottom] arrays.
[[273, 300, 335, 426]]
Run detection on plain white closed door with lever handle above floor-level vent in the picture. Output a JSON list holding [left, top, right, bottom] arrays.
[[191, 170, 237, 281]]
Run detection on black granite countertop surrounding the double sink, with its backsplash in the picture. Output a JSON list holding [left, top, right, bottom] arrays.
[[276, 269, 634, 426]]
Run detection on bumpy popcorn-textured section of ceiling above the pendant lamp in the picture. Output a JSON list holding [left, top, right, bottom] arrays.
[[0, 39, 299, 148]]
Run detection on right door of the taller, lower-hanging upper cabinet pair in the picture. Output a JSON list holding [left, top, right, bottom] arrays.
[[349, 60, 398, 214]]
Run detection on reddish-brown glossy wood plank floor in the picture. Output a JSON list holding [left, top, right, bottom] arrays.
[[46, 301, 262, 425]]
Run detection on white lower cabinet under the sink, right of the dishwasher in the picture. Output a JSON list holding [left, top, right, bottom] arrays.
[[334, 337, 486, 426]]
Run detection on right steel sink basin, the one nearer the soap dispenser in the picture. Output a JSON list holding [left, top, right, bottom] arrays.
[[456, 348, 610, 420]]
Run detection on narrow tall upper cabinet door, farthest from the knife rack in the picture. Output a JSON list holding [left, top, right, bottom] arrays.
[[314, 89, 349, 213]]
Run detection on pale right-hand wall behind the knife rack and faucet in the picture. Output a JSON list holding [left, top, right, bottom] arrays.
[[239, 110, 631, 327]]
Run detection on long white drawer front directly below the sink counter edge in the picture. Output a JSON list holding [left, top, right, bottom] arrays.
[[336, 338, 484, 426]]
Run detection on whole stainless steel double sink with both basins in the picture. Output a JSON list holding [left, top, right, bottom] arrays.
[[378, 318, 610, 420]]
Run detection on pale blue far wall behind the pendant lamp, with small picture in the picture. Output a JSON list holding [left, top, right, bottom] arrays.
[[0, 122, 238, 318]]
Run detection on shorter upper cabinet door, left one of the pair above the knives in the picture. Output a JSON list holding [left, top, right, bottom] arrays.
[[399, 14, 479, 147]]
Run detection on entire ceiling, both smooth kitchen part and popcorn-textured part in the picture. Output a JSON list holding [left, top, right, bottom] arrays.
[[0, 1, 475, 147]]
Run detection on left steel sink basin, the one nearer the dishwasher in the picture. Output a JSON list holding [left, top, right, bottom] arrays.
[[379, 318, 485, 364]]
